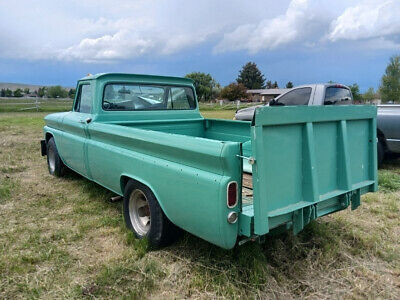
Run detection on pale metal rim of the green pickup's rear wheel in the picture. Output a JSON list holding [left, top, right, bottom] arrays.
[[129, 189, 150, 236]]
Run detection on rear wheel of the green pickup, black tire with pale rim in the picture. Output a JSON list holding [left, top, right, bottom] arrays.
[[123, 180, 180, 248]]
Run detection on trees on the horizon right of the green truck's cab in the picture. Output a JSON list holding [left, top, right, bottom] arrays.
[[185, 55, 400, 103]]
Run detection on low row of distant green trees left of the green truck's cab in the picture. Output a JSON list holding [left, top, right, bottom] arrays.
[[0, 85, 75, 99]]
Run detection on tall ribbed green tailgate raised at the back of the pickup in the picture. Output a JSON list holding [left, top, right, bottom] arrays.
[[247, 106, 377, 235]]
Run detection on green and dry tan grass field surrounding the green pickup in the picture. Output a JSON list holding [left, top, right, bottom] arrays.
[[0, 110, 400, 299]]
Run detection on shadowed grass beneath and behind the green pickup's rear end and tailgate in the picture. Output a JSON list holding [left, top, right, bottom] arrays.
[[160, 219, 367, 298]]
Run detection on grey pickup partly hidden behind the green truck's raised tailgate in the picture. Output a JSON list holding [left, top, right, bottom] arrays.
[[235, 84, 400, 165]]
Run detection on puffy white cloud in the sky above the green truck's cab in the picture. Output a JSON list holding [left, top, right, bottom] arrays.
[[57, 19, 212, 62]]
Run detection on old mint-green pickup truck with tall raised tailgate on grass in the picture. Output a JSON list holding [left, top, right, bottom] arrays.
[[41, 73, 377, 249]]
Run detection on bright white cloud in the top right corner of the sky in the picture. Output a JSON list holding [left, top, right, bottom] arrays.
[[328, 0, 400, 44]]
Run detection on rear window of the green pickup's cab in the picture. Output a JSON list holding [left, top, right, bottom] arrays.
[[103, 83, 196, 111]]
